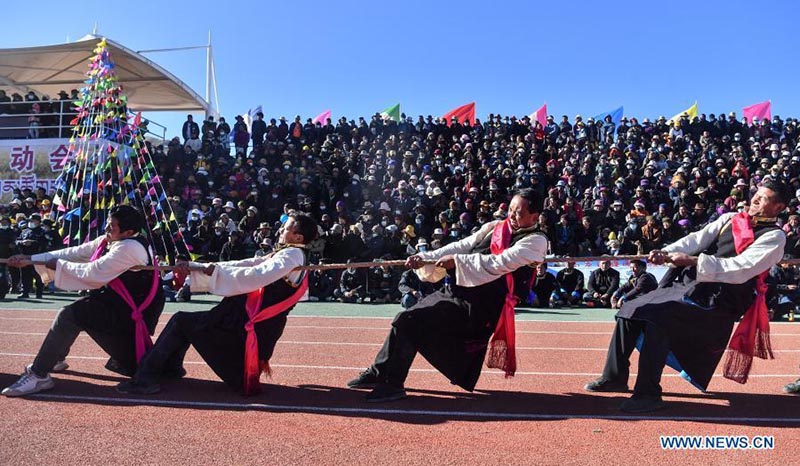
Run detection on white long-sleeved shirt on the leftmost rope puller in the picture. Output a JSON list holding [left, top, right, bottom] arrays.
[[31, 236, 148, 291]]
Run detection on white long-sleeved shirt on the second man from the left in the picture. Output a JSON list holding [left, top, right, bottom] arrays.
[[191, 247, 305, 296]]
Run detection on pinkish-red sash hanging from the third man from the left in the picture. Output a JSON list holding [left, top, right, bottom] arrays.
[[486, 219, 517, 377]]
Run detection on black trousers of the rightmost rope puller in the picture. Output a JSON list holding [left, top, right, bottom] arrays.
[[602, 318, 670, 397]]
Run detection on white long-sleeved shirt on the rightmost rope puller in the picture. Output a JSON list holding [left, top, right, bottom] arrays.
[[664, 213, 786, 284]]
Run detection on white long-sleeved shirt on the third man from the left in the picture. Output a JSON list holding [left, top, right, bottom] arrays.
[[417, 221, 547, 287]]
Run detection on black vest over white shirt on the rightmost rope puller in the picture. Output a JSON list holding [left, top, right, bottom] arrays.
[[684, 221, 778, 317]]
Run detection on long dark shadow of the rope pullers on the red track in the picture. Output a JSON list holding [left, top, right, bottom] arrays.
[[0, 373, 800, 428]]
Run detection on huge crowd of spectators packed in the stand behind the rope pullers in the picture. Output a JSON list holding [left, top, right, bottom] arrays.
[[4, 107, 800, 305]]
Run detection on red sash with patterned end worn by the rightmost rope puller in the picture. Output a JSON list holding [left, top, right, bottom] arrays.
[[723, 212, 774, 384]]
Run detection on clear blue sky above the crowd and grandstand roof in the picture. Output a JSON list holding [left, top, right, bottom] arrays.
[[0, 0, 800, 136]]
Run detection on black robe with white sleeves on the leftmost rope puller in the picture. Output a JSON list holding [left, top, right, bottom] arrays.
[[31, 235, 164, 373]]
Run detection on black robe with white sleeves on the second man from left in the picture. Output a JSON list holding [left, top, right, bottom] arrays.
[[182, 247, 307, 388]]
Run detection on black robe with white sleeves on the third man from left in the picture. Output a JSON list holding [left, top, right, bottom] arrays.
[[400, 222, 547, 391]]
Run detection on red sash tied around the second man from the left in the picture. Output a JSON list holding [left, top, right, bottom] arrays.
[[244, 274, 308, 395]]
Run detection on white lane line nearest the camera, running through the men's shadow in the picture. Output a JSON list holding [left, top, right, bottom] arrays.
[[21, 394, 800, 424]]
